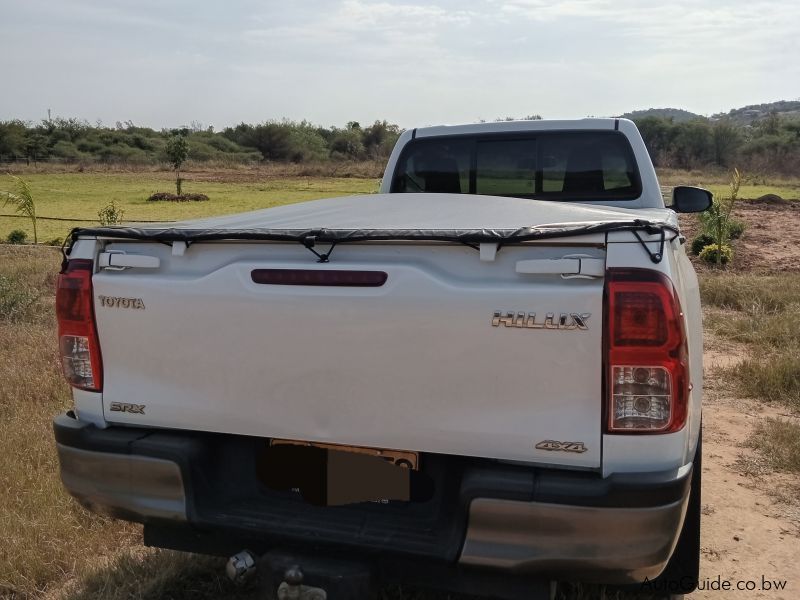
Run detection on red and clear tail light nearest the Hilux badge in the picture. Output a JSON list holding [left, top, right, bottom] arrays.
[[605, 269, 690, 433]]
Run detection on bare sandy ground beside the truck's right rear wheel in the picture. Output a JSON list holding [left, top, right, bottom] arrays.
[[691, 337, 800, 600]]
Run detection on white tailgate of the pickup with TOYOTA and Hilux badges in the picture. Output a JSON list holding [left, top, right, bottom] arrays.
[[93, 242, 604, 468]]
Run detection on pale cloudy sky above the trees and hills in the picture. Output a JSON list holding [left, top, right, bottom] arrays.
[[0, 0, 800, 129]]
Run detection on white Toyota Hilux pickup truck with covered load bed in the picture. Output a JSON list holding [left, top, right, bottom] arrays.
[[54, 119, 711, 598]]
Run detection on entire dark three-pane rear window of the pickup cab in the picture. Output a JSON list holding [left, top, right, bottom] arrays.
[[391, 131, 642, 201]]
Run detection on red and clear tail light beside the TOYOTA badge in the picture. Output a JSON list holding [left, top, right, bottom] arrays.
[[56, 259, 103, 392]]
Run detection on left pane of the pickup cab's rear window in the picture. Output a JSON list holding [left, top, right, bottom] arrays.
[[392, 140, 473, 194]]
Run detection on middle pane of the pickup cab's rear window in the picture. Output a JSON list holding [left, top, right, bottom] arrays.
[[475, 139, 536, 196]]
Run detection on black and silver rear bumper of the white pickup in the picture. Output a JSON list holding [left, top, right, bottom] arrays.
[[54, 415, 691, 583]]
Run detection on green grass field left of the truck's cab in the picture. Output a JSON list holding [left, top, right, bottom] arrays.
[[0, 172, 378, 242]]
